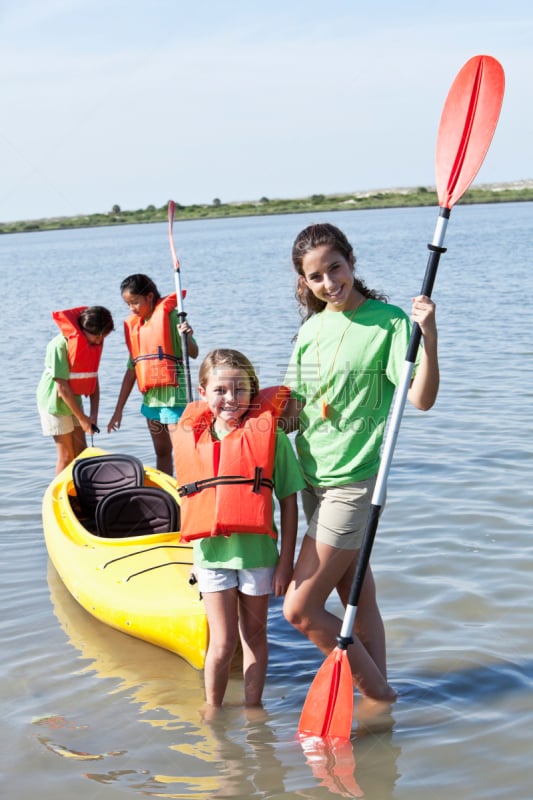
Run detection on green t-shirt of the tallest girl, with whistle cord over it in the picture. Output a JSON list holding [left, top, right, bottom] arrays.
[[285, 299, 418, 486]]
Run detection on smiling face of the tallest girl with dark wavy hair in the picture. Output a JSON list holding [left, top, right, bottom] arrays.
[[302, 244, 360, 311]]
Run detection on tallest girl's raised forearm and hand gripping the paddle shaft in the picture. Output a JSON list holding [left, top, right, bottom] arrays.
[[407, 295, 440, 411]]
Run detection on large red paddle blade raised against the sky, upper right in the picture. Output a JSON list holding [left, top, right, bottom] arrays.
[[436, 56, 505, 208]]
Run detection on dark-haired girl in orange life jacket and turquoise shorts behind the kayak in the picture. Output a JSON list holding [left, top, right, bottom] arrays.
[[107, 273, 198, 475]]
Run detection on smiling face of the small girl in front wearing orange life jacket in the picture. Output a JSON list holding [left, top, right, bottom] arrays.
[[198, 367, 252, 432]]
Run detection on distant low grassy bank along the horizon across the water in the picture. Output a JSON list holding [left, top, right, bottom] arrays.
[[0, 181, 533, 238]]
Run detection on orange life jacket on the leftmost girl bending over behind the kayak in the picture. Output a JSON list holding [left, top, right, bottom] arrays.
[[52, 306, 103, 396]]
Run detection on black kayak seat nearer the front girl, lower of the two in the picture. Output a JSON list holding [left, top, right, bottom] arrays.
[[96, 486, 180, 538]]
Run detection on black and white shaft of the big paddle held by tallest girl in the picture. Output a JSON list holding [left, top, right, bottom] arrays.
[[337, 208, 450, 649]]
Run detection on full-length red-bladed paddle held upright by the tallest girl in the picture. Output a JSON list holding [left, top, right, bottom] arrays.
[[298, 56, 505, 739]]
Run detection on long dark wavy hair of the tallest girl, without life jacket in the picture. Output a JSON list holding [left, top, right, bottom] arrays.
[[292, 222, 387, 321]]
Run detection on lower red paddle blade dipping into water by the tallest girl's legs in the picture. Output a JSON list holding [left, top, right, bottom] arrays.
[[298, 647, 353, 739]]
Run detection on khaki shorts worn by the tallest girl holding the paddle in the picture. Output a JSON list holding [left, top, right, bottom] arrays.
[[302, 475, 376, 550]]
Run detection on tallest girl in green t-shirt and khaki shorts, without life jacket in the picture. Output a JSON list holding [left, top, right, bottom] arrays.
[[284, 224, 439, 702]]
